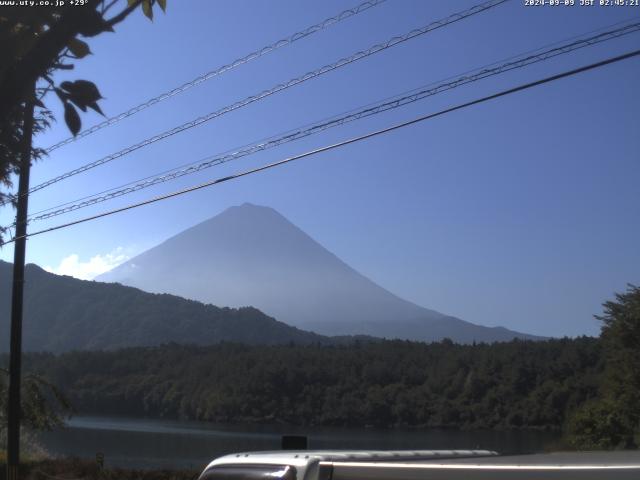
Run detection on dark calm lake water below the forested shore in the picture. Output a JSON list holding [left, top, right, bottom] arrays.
[[39, 416, 558, 470]]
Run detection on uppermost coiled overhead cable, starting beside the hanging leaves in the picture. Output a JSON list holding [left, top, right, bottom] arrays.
[[46, 0, 386, 153]]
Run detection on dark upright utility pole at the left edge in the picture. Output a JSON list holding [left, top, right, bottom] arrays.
[[7, 85, 35, 480]]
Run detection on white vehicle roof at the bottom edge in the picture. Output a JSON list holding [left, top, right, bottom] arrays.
[[203, 450, 640, 480]]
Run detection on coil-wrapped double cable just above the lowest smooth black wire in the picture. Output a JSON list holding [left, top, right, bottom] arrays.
[[29, 18, 640, 222]]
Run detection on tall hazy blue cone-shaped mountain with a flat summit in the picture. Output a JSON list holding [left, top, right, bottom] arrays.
[[96, 203, 534, 342]]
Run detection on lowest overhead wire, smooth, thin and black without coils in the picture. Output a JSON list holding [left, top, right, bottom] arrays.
[[0, 50, 640, 246]]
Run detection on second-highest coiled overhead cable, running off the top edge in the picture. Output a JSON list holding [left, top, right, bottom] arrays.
[[15, 0, 508, 205]]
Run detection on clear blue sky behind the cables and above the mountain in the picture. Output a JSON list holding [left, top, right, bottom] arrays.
[[0, 0, 640, 336]]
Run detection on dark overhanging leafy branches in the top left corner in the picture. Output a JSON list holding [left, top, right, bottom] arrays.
[[0, 0, 166, 217]]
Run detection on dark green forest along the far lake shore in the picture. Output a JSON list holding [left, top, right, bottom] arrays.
[[17, 337, 602, 428]]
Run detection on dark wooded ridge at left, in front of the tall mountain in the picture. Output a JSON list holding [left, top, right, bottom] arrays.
[[0, 262, 329, 352]]
